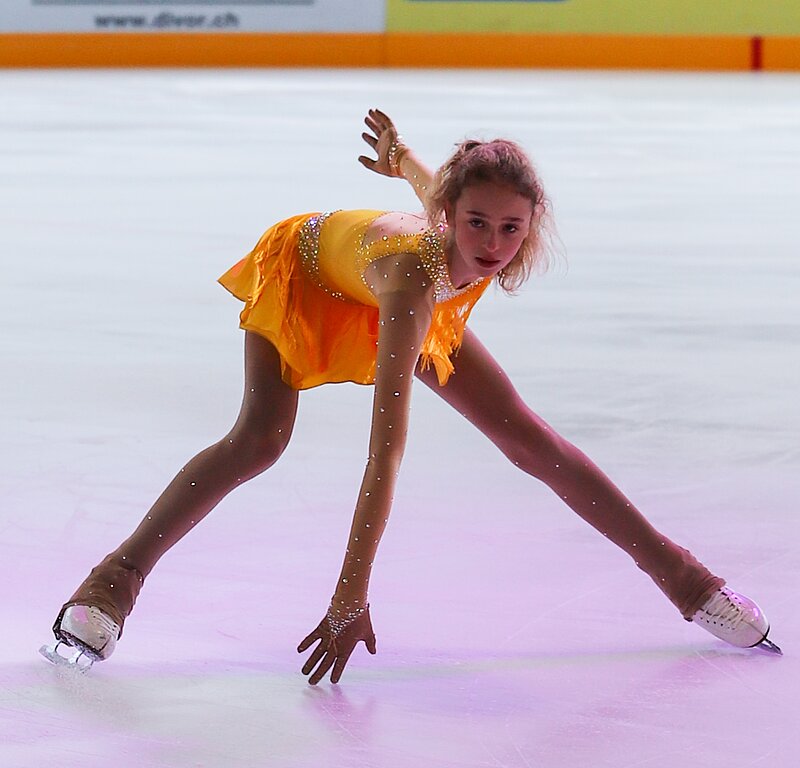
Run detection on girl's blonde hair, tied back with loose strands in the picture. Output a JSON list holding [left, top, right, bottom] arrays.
[[425, 139, 552, 293]]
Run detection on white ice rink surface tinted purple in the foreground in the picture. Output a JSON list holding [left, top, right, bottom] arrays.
[[0, 71, 800, 768]]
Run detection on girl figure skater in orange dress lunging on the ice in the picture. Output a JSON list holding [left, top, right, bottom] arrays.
[[42, 110, 779, 684]]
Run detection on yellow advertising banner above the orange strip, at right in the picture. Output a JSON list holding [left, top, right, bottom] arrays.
[[387, 0, 800, 36]]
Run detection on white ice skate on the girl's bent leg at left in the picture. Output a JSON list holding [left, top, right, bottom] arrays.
[[39, 605, 120, 672]]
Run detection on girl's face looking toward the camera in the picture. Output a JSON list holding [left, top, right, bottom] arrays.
[[445, 181, 533, 286]]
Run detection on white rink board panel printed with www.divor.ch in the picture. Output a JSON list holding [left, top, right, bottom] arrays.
[[0, 0, 386, 33]]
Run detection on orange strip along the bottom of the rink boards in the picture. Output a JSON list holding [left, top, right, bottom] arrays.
[[0, 32, 800, 71]]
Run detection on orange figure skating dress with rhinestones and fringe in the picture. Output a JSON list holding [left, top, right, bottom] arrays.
[[219, 210, 491, 389]]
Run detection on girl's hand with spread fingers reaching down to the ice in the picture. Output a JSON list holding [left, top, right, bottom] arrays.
[[297, 606, 376, 685]]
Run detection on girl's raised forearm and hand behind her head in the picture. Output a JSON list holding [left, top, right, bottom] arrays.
[[358, 109, 433, 208]]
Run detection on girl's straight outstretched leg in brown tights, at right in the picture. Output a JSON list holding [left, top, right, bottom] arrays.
[[417, 330, 724, 620]]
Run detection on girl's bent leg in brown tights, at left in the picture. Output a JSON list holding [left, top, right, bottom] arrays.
[[56, 332, 297, 628]]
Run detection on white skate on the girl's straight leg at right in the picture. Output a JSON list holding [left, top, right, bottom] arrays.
[[692, 587, 783, 654]]
